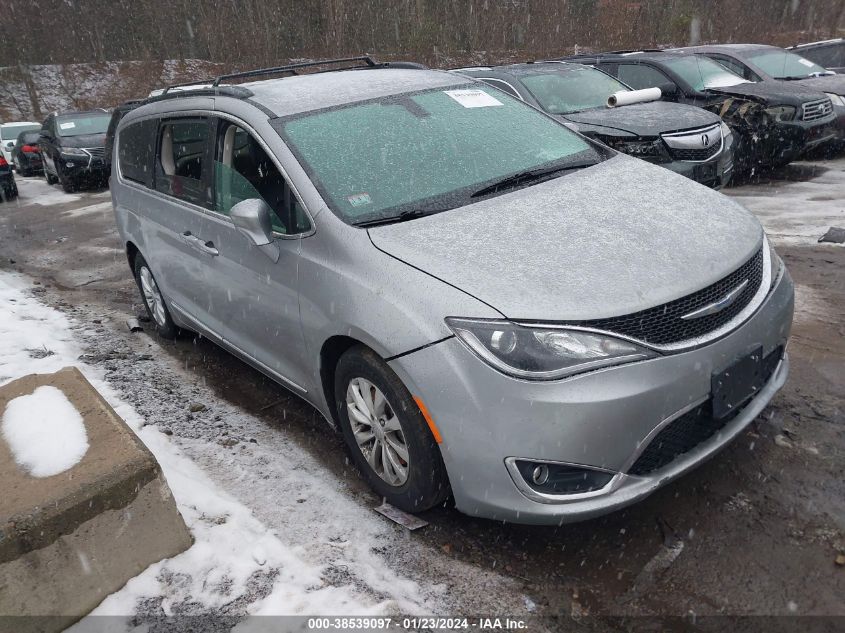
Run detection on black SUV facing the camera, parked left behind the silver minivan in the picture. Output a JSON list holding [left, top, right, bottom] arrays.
[[39, 110, 111, 193]]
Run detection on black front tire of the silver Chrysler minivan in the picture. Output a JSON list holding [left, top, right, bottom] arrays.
[[335, 345, 449, 512]]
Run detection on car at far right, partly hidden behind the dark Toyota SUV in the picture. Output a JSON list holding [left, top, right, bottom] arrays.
[[680, 44, 845, 147]]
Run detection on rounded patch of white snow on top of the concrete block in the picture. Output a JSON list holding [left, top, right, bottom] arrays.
[[2, 386, 89, 477]]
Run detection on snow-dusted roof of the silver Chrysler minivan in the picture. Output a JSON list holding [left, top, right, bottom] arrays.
[[244, 68, 472, 116]]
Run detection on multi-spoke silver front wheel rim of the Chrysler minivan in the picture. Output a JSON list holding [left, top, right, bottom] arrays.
[[346, 378, 410, 487]]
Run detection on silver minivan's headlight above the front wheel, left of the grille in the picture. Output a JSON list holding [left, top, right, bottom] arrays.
[[446, 317, 658, 380]]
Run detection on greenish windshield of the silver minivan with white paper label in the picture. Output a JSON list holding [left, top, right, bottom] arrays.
[[280, 85, 601, 224]]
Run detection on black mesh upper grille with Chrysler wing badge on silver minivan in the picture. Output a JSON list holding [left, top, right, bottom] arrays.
[[568, 248, 763, 345]]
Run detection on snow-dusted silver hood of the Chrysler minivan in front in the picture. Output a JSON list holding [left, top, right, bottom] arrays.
[[369, 154, 763, 321]]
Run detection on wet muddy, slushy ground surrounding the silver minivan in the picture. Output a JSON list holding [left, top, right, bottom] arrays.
[[0, 164, 845, 620]]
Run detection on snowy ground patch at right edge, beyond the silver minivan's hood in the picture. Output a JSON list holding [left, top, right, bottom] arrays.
[[724, 158, 845, 247]]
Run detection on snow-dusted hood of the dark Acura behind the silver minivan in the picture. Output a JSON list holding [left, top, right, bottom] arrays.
[[561, 101, 720, 136]]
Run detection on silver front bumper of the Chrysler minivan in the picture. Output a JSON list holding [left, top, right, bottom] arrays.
[[390, 270, 794, 524]]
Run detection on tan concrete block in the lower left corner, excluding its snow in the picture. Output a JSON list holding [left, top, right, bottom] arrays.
[[0, 367, 192, 633]]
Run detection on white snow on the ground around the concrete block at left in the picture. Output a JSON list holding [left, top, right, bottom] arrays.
[[0, 273, 402, 631]]
